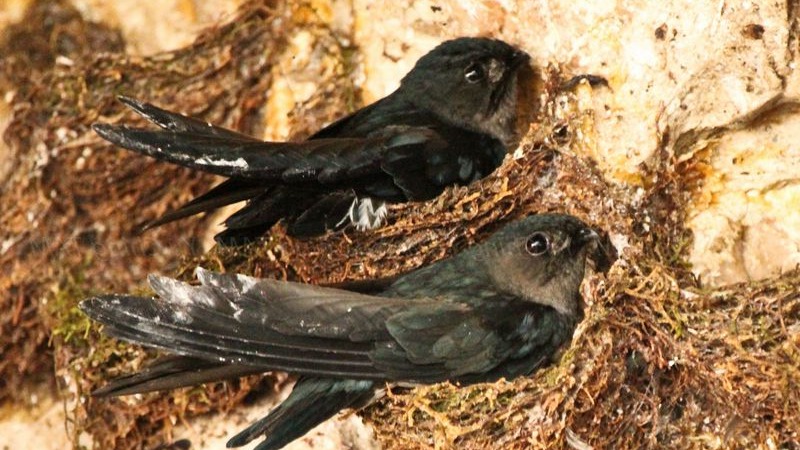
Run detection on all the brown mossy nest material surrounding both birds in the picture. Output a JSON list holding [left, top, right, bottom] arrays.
[[0, 2, 800, 449]]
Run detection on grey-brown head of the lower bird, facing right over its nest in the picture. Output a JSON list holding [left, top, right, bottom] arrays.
[[482, 214, 598, 316]]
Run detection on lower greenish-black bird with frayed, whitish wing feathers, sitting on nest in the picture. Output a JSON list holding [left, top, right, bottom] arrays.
[[80, 214, 598, 450]]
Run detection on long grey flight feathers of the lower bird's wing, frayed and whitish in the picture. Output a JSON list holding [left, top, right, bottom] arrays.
[[81, 271, 424, 379]]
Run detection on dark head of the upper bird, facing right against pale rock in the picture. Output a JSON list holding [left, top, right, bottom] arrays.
[[400, 38, 530, 144]]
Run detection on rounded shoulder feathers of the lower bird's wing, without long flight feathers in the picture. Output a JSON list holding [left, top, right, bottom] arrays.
[[371, 293, 574, 383]]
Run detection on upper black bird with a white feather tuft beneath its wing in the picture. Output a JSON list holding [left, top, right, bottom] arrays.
[[92, 37, 530, 245]]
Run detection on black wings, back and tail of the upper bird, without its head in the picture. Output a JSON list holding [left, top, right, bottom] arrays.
[[94, 97, 505, 244]]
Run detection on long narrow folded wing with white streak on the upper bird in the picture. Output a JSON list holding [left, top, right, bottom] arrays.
[[93, 109, 444, 184]]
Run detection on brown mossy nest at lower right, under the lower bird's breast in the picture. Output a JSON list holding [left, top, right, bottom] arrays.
[[366, 261, 800, 449]]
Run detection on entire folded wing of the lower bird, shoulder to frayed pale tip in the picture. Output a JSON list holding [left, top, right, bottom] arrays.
[[81, 270, 552, 382]]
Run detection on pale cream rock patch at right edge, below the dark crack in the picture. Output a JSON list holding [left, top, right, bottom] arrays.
[[688, 112, 800, 285]]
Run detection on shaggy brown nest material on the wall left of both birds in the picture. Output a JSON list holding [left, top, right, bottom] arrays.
[[0, 0, 357, 448]]
